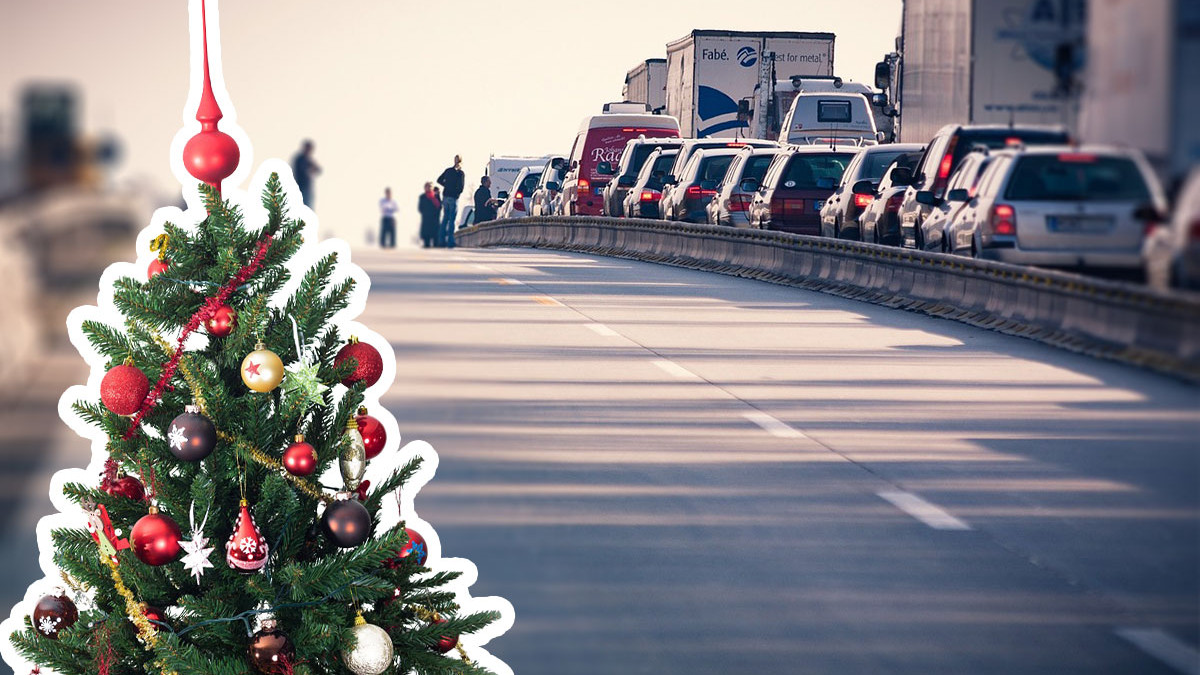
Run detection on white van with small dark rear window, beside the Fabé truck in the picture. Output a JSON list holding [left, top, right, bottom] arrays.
[[779, 91, 881, 145]]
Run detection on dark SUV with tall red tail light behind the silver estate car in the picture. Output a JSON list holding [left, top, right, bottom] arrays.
[[900, 124, 1070, 249]]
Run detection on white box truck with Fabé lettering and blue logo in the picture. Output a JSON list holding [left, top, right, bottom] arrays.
[[666, 30, 834, 138]]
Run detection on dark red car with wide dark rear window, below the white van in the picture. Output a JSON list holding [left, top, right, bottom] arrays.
[[742, 145, 858, 235]]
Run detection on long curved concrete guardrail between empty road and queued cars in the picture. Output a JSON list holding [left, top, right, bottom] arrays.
[[457, 216, 1200, 382]]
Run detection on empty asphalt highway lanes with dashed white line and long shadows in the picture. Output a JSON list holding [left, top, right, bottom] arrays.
[[356, 249, 1200, 675]]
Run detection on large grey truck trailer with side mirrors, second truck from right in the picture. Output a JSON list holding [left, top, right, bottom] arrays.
[[876, 0, 1087, 143]]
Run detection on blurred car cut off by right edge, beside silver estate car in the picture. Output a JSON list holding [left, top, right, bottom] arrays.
[[1142, 168, 1200, 289]]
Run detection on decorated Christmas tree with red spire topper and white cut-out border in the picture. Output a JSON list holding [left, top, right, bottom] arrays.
[[4, 0, 511, 675]]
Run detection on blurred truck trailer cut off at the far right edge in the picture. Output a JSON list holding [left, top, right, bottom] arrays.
[[1079, 0, 1200, 186]]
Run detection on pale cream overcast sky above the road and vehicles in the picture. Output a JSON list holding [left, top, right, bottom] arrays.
[[0, 0, 900, 245]]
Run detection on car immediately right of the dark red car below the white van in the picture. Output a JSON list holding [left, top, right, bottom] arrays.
[[821, 143, 924, 241]]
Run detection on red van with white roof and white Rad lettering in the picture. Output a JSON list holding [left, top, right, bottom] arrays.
[[562, 113, 679, 216]]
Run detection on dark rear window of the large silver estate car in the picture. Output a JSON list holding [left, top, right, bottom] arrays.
[[1004, 154, 1150, 202]]
